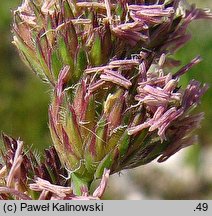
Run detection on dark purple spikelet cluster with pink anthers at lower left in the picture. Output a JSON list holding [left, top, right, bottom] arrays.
[[0, 134, 110, 200]]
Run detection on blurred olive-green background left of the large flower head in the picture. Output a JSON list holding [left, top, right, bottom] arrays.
[[0, 0, 50, 149]]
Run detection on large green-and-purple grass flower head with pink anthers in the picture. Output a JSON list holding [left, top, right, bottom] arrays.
[[0, 0, 212, 198]]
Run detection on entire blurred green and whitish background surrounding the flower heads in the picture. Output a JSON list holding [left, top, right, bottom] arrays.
[[0, 0, 212, 199]]
